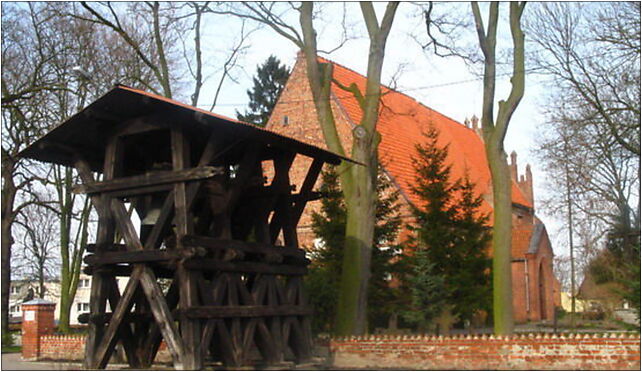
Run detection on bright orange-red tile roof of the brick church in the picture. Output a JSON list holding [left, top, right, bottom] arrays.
[[321, 59, 532, 218]]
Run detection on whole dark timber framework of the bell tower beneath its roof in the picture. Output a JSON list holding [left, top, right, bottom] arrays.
[[75, 120, 324, 369]]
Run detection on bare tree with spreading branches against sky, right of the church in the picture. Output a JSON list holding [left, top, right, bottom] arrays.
[[528, 3, 640, 326]]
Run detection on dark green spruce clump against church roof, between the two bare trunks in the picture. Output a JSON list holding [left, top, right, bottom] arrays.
[[404, 127, 492, 327]]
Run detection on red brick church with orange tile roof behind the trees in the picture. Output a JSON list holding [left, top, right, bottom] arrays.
[[267, 54, 560, 322]]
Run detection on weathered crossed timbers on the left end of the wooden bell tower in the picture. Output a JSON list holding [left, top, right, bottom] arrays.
[[75, 123, 226, 369]]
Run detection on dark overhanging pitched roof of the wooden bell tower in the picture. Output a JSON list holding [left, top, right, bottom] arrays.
[[19, 85, 354, 172]]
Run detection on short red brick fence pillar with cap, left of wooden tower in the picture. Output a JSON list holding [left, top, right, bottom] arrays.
[[22, 298, 56, 359]]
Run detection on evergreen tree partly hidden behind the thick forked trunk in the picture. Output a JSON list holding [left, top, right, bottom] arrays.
[[306, 168, 401, 333]]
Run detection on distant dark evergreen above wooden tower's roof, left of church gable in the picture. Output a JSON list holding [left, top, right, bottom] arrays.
[[236, 56, 290, 127]]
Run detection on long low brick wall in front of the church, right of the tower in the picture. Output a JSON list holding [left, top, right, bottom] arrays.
[[330, 334, 640, 370]]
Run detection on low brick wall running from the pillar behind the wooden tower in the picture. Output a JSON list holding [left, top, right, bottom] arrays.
[[39, 335, 172, 363]]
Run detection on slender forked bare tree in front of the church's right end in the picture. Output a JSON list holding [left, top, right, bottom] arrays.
[[472, 2, 526, 334]]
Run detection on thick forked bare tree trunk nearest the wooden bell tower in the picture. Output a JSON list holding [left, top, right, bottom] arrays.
[[299, 2, 392, 335]]
